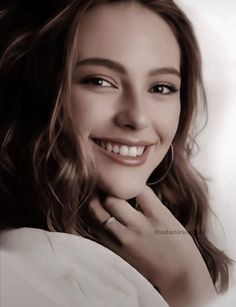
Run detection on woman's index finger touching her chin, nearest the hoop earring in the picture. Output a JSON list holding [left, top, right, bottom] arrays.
[[136, 186, 165, 217]]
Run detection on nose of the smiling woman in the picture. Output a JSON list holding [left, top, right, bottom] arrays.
[[115, 93, 149, 130]]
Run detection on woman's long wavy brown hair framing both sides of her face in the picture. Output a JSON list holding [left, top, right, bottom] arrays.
[[0, 0, 230, 292]]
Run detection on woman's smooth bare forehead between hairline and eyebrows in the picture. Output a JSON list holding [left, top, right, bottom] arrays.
[[77, 3, 180, 69]]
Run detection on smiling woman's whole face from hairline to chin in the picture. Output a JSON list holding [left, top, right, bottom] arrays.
[[72, 4, 181, 199]]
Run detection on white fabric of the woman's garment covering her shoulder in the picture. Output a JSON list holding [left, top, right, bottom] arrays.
[[0, 228, 168, 307]]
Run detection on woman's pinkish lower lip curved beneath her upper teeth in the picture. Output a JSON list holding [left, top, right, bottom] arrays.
[[92, 141, 151, 166]]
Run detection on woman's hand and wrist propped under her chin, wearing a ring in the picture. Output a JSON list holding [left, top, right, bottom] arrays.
[[90, 186, 218, 307]]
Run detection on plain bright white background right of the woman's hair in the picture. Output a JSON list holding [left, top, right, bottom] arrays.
[[177, 0, 236, 294]]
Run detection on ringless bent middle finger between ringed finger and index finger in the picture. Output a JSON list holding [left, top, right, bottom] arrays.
[[102, 197, 144, 229]]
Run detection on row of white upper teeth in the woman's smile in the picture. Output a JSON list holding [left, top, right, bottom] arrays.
[[93, 141, 145, 157]]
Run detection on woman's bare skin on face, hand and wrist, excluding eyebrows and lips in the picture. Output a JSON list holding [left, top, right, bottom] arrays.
[[72, 4, 215, 307]]
